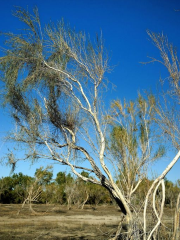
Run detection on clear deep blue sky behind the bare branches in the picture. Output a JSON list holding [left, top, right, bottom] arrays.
[[0, 0, 180, 181]]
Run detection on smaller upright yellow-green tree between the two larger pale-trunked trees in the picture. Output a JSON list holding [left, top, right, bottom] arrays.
[[108, 94, 165, 203]]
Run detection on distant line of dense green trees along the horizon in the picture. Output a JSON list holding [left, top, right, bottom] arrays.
[[0, 167, 180, 208]]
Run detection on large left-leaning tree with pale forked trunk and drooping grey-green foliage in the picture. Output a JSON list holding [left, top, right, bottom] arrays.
[[0, 8, 132, 229]]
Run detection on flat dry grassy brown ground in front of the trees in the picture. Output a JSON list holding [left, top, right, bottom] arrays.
[[0, 204, 172, 240]]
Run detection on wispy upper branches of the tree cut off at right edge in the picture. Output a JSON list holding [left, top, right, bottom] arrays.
[[148, 31, 180, 150]]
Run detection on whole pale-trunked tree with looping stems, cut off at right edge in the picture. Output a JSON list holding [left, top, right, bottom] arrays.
[[141, 31, 180, 240]]
